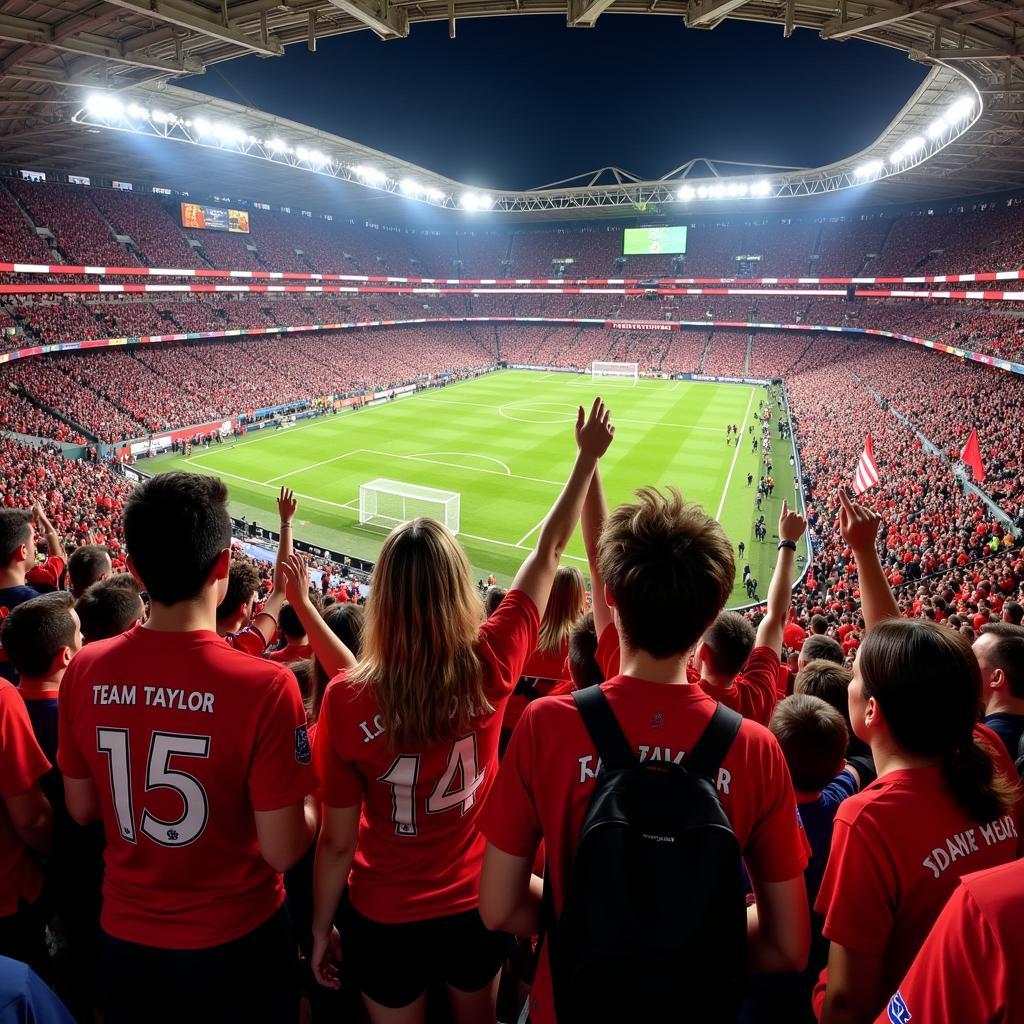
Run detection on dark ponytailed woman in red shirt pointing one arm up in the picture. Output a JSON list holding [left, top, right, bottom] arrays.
[[815, 494, 1019, 1024]]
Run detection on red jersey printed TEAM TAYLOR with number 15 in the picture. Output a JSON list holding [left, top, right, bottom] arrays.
[[57, 626, 315, 949]]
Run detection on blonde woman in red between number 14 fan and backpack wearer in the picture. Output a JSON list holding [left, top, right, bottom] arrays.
[[500, 565, 587, 757]]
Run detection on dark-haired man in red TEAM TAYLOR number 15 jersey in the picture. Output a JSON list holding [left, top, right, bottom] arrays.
[[58, 473, 315, 1024]]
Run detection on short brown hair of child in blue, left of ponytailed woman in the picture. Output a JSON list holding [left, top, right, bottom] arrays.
[[768, 693, 850, 793]]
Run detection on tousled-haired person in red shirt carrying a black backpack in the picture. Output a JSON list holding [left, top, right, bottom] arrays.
[[480, 476, 810, 1024]]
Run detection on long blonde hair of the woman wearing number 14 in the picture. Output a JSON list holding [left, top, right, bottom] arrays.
[[349, 518, 494, 749]]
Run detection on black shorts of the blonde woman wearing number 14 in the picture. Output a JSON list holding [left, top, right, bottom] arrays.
[[340, 896, 509, 1010]]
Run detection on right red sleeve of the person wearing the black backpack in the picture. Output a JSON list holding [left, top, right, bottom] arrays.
[[743, 730, 810, 882]]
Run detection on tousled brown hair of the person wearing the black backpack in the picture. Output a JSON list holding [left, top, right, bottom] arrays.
[[598, 487, 736, 657]]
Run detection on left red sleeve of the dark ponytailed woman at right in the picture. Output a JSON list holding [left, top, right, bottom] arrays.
[[814, 809, 898, 954]]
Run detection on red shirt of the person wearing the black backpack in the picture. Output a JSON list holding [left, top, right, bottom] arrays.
[[480, 676, 807, 1024]]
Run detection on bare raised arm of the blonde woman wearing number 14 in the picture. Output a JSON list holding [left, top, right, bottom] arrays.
[[512, 398, 615, 616]]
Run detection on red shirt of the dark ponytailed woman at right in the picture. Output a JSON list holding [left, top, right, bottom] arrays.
[[815, 767, 1018, 1012]]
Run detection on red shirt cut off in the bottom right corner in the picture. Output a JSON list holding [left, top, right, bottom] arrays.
[[878, 860, 1024, 1024]]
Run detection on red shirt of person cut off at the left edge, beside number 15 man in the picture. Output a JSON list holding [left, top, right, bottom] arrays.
[[0, 679, 50, 916]]
